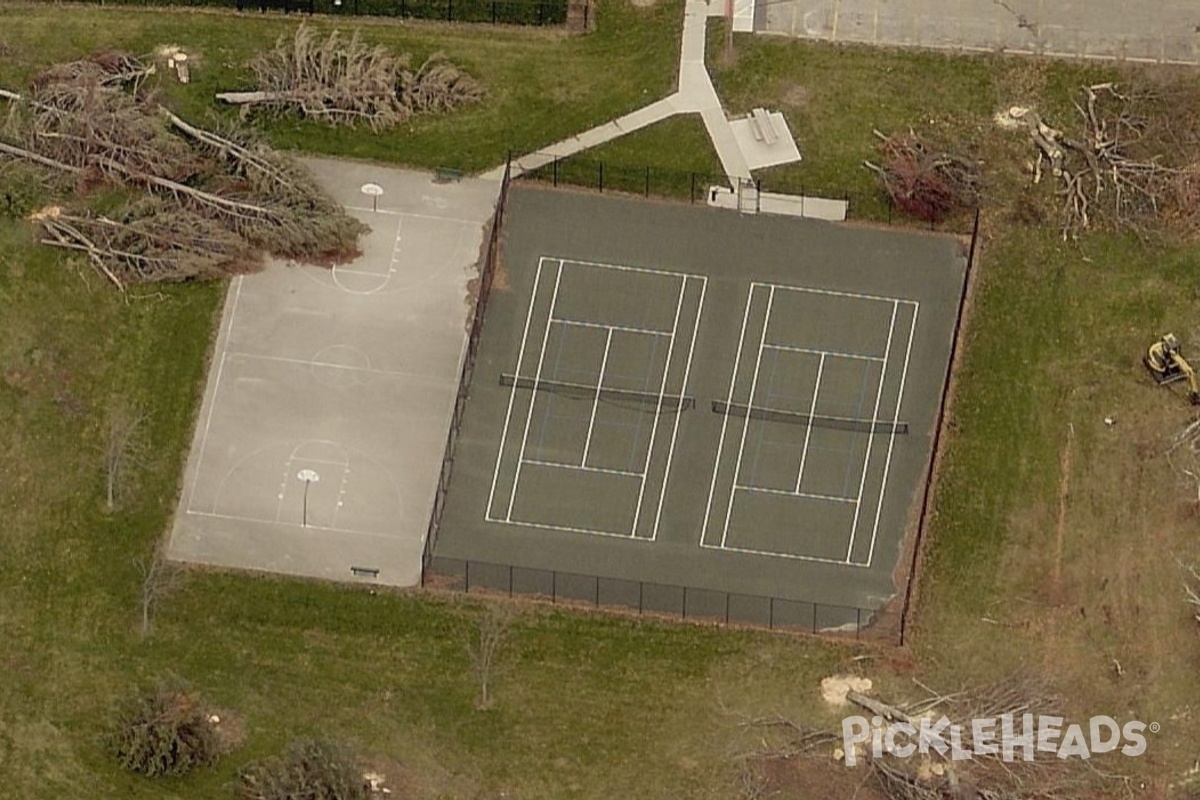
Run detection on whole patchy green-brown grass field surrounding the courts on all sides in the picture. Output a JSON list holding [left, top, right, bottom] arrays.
[[7, 1, 1200, 800]]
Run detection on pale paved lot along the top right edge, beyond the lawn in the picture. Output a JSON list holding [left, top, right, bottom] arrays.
[[755, 0, 1200, 64]]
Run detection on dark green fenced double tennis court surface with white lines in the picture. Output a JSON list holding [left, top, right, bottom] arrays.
[[431, 186, 965, 627]]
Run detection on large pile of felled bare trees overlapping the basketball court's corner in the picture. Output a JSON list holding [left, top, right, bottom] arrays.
[[0, 53, 366, 289]]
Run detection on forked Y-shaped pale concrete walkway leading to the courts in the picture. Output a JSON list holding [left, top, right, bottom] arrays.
[[481, 0, 750, 185]]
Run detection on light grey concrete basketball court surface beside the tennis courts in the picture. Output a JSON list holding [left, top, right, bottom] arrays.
[[168, 160, 499, 585]]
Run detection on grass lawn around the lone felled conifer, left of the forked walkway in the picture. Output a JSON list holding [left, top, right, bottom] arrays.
[[0, 1, 683, 172]]
